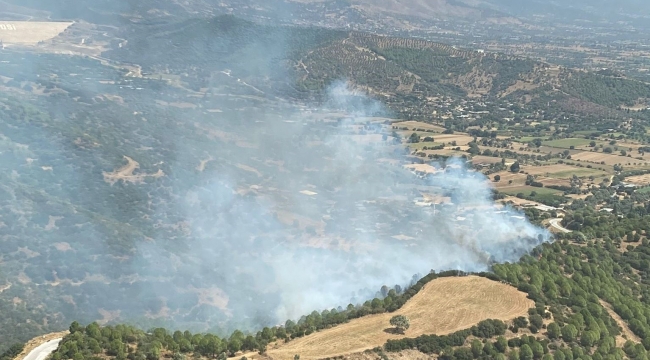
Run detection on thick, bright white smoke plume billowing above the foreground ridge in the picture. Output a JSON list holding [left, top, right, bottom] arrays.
[[140, 83, 549, 322]]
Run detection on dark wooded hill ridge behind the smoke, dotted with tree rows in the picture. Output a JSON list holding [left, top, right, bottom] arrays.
[[106, 16, 650, 120]]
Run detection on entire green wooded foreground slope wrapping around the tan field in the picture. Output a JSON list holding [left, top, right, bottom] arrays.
[[39, 239, 650, 360]]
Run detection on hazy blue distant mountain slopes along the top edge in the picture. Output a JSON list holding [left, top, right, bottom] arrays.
[[0, 0, 650, 25]]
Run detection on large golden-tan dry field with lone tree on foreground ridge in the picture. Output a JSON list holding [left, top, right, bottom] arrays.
[[268, 276, 534, 360]]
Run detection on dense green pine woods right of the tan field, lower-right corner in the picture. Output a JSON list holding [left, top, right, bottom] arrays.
[[385, 240, 650, 360]]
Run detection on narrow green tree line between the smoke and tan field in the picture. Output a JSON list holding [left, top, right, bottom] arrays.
[[53, 270, 474, 360]]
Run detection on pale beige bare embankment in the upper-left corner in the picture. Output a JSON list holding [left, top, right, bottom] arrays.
[[0, 21, 73, 45]]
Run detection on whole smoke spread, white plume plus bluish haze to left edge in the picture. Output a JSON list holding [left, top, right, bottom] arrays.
[[0, 8, 549, 340]]
